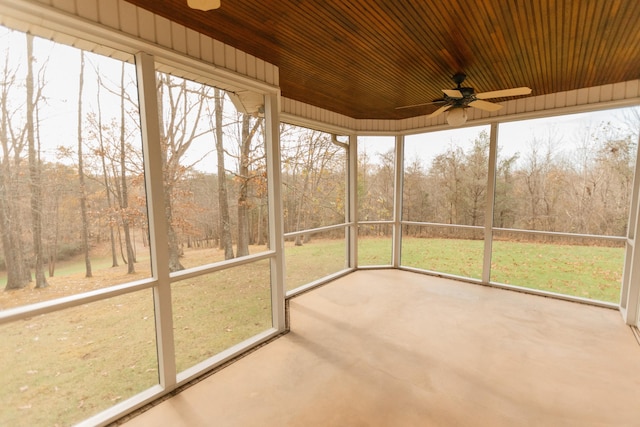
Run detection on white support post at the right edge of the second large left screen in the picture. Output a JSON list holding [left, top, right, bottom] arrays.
[[264, 94, 287, 331]]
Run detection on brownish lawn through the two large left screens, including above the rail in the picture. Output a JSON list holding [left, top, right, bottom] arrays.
[[0, 244, 271, 426]]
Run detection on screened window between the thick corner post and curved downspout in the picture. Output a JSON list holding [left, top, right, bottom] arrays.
[[280, 124, 348, 290]]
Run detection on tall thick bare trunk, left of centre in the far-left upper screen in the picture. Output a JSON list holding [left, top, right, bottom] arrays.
[[26, 34, 49, 289]]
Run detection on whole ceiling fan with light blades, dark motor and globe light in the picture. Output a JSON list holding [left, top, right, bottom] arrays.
[[398, 73, 531, 126]]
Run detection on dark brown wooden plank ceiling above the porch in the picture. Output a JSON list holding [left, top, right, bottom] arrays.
[[127, 0, 640, 119]]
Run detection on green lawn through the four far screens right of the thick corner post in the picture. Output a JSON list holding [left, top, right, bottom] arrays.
[[285, 237, 624, 303]]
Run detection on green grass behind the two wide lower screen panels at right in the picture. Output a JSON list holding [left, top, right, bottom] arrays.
[[401, 237, 624, 303]]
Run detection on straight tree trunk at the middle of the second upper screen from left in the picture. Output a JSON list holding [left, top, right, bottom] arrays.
[[215, 89, 233, 259]]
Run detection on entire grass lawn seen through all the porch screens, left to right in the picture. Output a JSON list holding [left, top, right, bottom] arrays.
[[0, 237, 624, 426]]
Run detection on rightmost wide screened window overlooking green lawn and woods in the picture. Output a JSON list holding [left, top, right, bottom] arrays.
[[491, 109, 637, 303]]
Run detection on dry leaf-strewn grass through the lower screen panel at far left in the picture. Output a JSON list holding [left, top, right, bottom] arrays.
[[0, 290, 158, 426]]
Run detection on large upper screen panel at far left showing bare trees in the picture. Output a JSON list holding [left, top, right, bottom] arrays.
[[0, 28, 151, 308]]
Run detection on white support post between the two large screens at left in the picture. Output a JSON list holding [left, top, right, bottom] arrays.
[[136, 53, 176, 390]]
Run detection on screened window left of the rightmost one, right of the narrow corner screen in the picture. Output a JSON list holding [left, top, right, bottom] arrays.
[[401, 126, 490, 278]]
